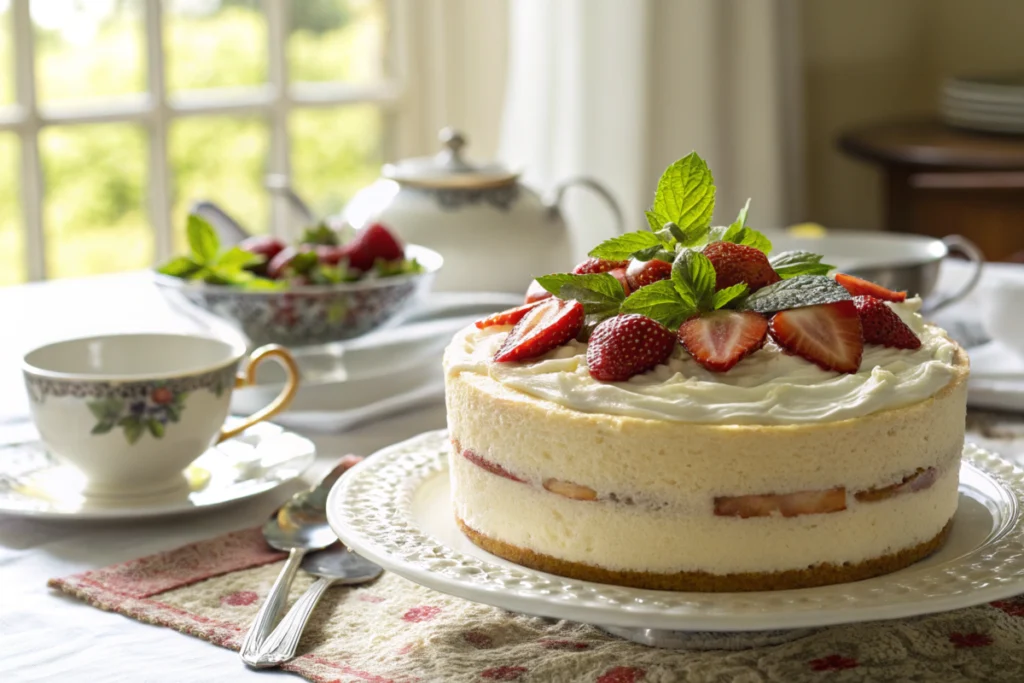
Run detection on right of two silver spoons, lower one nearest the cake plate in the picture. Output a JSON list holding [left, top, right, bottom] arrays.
[[245, 544, 384, 668]]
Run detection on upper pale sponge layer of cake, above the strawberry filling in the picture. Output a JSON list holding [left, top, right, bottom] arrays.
[[445, 350, 968, 501]]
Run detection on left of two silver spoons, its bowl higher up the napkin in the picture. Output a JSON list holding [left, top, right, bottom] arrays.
[[239, 458, 354, 667]]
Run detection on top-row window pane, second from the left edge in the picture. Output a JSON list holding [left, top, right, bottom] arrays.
[[31, 0, 145, 102]]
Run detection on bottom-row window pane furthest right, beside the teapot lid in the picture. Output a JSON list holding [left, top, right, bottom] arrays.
[[289, 104, 383, 215]]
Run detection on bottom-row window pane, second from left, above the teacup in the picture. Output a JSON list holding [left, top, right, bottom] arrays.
[[40, 124, 154, 278]]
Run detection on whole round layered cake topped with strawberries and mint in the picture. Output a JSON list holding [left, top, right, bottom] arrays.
[[444, 155, 968, 591]]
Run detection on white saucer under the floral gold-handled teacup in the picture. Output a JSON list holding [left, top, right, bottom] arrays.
[[0, 422, 316, 520]]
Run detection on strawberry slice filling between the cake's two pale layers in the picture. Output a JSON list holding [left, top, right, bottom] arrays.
[[452, 439, 938, 519]]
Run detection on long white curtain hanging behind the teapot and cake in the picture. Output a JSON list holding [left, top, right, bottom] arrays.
[[500, 0, 803, 256]]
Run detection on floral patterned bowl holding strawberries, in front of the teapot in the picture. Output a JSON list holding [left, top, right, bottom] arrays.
[[155, 245, 443, 347]]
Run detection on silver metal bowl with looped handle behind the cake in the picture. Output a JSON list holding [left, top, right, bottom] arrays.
[[769, 230, 985, 313]]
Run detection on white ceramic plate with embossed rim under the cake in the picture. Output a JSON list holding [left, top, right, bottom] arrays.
[[328, 431, 1024, 631]]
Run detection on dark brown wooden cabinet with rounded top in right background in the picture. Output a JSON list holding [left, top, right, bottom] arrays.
[[839, 121, 1024, 261]]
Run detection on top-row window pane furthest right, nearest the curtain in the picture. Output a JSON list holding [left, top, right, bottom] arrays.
[[288, 0, 387, 83]]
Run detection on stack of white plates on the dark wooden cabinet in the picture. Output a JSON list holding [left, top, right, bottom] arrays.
[[942, 73, 1024, 134]]
